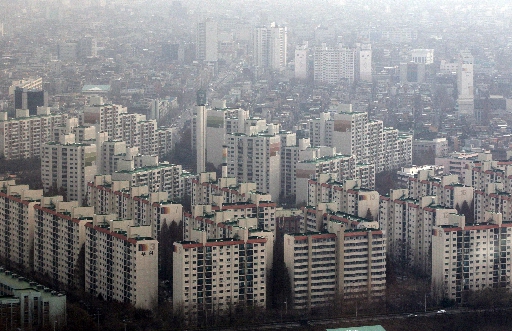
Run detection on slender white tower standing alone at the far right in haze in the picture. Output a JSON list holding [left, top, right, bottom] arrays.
[[457, 50, 475, 115]]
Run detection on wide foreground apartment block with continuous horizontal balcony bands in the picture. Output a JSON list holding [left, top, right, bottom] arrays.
[[284, 220, 386, 311]]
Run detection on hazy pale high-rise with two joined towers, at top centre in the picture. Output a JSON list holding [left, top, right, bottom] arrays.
[[253, 22, 288, 70]]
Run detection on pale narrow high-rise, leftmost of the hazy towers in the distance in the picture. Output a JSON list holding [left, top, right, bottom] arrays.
[[196, 19, 219, 62]]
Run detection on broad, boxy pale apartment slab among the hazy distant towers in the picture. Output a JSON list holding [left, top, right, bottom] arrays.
[[313, 44, 356, 84]]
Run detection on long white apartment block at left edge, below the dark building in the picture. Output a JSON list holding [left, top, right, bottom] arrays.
[[0, 107, 67, 160]]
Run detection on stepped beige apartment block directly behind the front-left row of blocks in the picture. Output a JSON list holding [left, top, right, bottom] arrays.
[[87, 176, 183, 238]]
